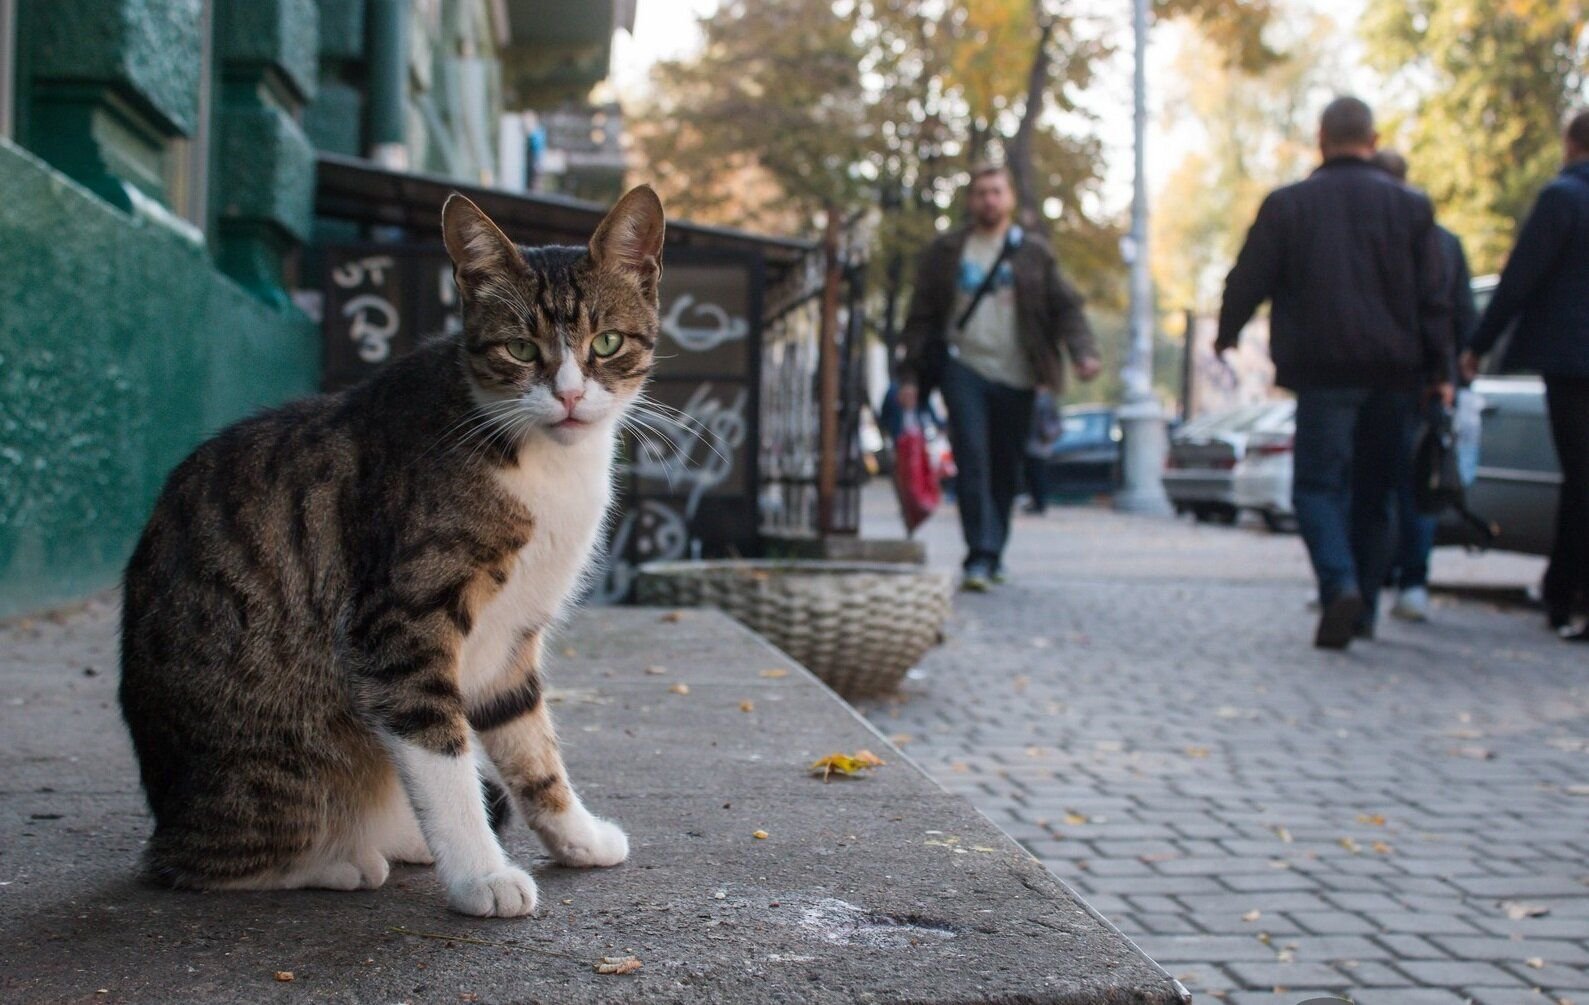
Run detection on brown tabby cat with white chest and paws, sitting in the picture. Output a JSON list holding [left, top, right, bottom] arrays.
[[119, 186, 664, 918]]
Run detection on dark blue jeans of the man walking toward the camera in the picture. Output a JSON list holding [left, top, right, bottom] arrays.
[[939, 359, 1034, 571]]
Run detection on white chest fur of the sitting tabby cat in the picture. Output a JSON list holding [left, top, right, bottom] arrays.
[[459, 431, 613, 697]]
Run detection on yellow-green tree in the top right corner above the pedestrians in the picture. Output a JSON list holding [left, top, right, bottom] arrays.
[[1362, 0, 1589, 274]]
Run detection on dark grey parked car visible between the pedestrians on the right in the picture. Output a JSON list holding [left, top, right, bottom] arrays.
[[1436, 275, 1562, 555]]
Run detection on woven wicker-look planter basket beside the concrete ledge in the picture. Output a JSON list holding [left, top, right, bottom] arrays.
[[636, 560, 950, 698]]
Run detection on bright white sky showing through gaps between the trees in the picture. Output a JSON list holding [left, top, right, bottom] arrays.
[[610, 0, 1365, 219]]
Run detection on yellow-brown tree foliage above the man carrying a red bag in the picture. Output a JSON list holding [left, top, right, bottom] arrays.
[[631, 0, 1119, 298]]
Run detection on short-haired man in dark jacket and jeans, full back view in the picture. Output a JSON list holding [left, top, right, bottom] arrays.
[[1216, 97, 1454, 649]]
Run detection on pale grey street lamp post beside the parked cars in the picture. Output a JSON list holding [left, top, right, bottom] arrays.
[[1114, 0, 1170, 514]]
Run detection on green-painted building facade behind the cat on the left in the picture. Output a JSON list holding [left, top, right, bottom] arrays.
[[0, 0, 632, 615]]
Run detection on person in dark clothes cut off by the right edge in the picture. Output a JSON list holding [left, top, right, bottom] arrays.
[[1462, 110, 1589, 641]]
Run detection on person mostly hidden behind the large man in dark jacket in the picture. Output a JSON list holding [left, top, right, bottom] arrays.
[[1374, 149, 1479, 622]]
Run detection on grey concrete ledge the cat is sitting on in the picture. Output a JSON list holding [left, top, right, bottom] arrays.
[[0, 601, 1185, 1005]]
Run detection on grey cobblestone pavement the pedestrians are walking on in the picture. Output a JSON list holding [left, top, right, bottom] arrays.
[[863, 483, 1589, 1005]]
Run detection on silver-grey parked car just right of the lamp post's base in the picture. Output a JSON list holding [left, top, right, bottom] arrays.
[[1163, 401, 1295, 523]]
